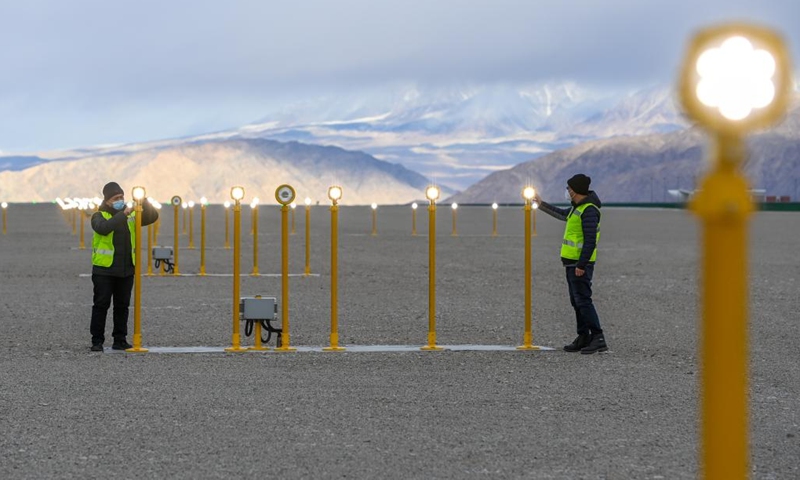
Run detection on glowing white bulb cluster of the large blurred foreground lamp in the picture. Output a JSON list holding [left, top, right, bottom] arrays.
[[695, 36, 776, 121]]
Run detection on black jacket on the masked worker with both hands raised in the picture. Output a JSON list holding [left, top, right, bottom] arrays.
[[92, 200, 158, 277]]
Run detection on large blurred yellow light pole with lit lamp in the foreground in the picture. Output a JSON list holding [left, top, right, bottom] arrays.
[[679, 24, 793, 480]]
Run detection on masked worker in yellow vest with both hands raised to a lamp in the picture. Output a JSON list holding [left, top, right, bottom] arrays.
[[89, 182, 158, 352]]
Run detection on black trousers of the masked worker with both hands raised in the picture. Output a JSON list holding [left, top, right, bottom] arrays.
[[89, 275, 133, 344]]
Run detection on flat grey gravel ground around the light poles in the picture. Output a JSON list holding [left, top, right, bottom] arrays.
[[0, 205, 800, 479]]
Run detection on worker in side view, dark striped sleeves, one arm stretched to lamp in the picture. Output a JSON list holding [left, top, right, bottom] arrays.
[[534, 173, 608, 354]]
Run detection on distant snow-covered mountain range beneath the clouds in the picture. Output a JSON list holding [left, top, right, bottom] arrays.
[[230, 83, 685, 188]]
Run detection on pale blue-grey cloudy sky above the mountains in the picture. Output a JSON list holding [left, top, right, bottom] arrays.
[[0, 0, 800, 154]]
